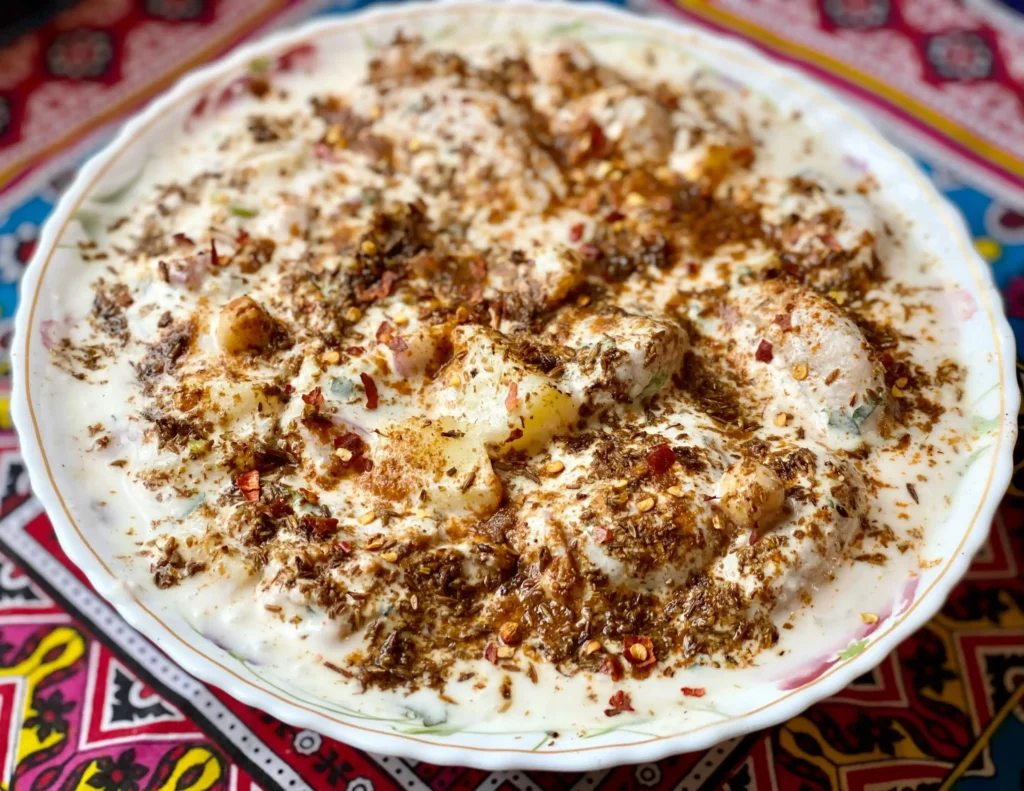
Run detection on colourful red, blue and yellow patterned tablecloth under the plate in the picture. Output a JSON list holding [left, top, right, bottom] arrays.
[[0, 0, 1024, 791]]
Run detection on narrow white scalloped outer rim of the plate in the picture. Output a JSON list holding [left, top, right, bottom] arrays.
[[11, 0, 1020, 772]]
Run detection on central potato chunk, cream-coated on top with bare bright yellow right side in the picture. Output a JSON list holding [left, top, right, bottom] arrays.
[[439, 326, 579, 456]]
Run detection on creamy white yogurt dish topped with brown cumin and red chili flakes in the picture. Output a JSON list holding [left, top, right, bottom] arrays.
[[44, 30, 972, 732]]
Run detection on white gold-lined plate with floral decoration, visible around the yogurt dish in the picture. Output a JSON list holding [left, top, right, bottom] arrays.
[[12, 2, 1019, 771]]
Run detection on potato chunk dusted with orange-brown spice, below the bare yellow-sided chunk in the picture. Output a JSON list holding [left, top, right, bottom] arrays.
[[371, 417, 502, 518]]
